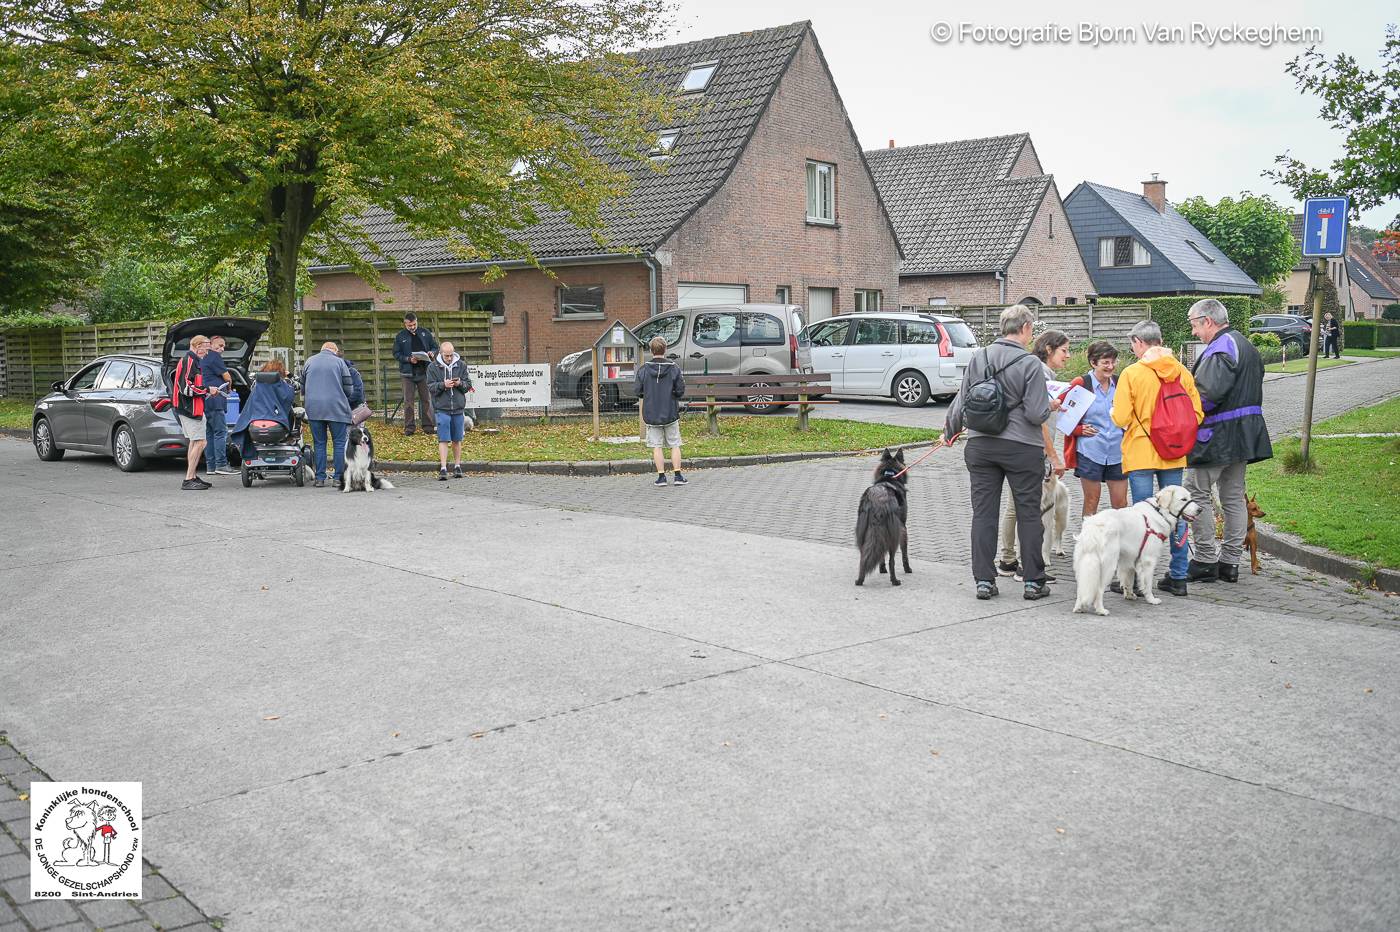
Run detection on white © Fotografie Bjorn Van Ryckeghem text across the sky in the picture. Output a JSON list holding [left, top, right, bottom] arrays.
[[928, 20, 1323, 49]]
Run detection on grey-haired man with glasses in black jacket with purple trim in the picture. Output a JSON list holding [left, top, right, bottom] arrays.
[[1186, 298, 1274, 582]]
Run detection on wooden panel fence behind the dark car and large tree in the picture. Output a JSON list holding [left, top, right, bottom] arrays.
[[0, 311, 491, 406]]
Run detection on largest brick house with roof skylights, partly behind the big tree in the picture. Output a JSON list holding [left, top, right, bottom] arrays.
[[304, 22, 900, 362]]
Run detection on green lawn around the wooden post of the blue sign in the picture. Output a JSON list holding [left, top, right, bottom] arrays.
[[1249, 399, 1400, 568]]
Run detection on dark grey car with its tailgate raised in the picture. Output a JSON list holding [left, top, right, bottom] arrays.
[[32, 318, 267, 473]]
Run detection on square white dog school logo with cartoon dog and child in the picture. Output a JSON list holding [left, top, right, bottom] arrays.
[[29, 782, 141, 900]]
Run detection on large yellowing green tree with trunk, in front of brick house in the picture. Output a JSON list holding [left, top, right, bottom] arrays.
[[0, 0, 675, 344]]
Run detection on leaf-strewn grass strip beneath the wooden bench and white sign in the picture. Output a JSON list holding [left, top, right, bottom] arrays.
[[371, 414, 939, 462]]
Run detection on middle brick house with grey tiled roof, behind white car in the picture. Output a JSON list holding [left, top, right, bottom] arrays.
[[865, 133, 1093, 306]]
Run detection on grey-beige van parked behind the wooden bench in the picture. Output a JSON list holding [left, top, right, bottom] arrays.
[[554, 304, 804, 411]]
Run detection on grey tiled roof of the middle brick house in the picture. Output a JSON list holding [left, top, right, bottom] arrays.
[[865, 133, 1053, 274]]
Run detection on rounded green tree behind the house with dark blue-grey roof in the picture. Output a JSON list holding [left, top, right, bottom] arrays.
[[1176, 192, 1301, 285]]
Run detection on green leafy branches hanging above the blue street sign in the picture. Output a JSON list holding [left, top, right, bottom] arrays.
[[1264, 24, 1400, 227]]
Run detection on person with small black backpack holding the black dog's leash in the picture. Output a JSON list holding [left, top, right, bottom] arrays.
[[944, 304, 1051, 599]]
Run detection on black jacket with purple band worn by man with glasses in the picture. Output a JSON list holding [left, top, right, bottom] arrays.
[[1186, 327, 1274, 466]]
